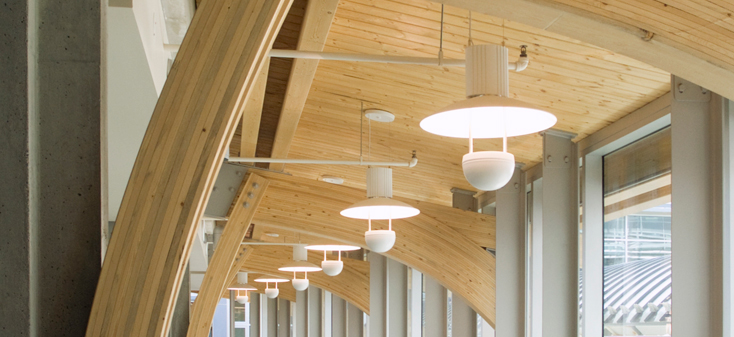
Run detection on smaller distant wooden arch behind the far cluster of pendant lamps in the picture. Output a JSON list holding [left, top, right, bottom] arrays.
[[242, 246, 370, 315]]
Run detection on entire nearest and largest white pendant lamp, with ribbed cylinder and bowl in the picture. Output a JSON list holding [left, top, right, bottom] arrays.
[[420, 45, 557, 191]]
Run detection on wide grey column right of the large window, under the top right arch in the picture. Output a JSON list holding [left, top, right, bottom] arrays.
[[671, 77, 731, 336]]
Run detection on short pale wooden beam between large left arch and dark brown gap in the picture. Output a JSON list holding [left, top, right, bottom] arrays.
[[240, 61, 270, 158]]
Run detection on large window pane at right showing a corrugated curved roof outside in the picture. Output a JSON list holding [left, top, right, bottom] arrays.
[[603, 129, 672, 336]]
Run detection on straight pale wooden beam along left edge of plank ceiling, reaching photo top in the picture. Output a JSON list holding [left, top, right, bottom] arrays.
[[270, 0, 339, 171]]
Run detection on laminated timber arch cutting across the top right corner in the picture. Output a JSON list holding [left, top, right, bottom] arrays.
[[438, 0, 734, 99]]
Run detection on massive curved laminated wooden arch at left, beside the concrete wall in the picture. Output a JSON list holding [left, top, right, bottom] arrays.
[[87, 0, 291, 337]]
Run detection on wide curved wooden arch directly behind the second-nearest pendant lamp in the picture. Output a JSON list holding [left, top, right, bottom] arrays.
[[253, 174, 495, 325]]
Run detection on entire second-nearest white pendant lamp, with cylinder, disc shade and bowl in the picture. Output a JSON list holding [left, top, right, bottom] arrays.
[[341, 167, 420, 253]]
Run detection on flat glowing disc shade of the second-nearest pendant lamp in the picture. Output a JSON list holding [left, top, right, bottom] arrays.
[[340, 197, 421, 220]]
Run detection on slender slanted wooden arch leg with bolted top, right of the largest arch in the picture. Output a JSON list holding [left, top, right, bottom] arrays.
[[187, 173, 268, 337]]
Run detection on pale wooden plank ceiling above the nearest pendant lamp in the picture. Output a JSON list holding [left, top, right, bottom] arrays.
[[232, 0, 670, 205]]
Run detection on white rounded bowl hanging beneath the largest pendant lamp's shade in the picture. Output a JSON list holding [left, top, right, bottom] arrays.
[[462, 151, 515, 191]]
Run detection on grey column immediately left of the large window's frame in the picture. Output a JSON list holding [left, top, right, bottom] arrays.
[[540, 130, 579, 337]]
